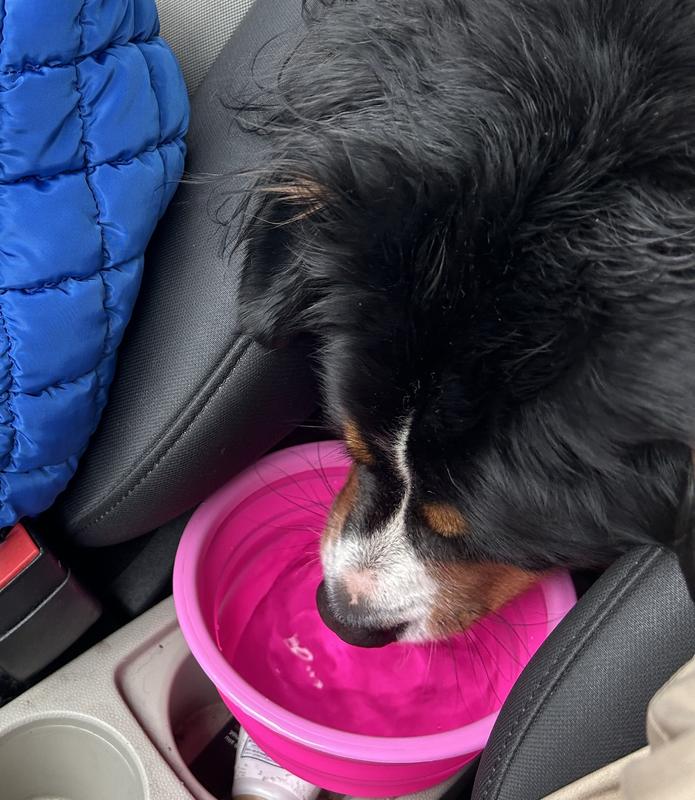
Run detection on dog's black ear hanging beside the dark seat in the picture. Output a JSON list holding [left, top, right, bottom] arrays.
[[239, 179, 325, 346]]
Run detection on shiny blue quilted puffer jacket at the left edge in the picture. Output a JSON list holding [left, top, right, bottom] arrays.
[[0, 0, 188, 526]]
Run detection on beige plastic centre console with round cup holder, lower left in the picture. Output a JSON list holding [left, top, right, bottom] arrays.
[[0, 600, 197, 800]]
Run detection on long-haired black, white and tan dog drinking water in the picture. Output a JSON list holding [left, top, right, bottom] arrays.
[[240, 0, 695, 646]]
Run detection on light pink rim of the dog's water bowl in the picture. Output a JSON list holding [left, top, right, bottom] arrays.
[[173, 441, 576, 764]]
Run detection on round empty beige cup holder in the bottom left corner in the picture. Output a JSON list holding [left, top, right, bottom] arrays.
[[0, 718, 146, 800]]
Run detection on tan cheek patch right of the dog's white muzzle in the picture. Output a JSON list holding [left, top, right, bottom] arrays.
[[428, 563, 543, 638]]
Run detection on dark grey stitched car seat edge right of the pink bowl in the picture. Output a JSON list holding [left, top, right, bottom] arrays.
[[473, 547, 695, 800]]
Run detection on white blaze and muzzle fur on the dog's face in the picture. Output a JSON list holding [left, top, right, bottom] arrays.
[[323, 416, 437, 640]]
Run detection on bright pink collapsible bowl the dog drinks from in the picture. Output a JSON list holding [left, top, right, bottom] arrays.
[[174, 442, 576, 797]]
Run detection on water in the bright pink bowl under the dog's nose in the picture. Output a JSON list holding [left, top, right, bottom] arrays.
[[217, 532, 546, 737]]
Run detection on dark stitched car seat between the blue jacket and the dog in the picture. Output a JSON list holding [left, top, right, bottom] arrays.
[[56, 0, 314, 546]]
